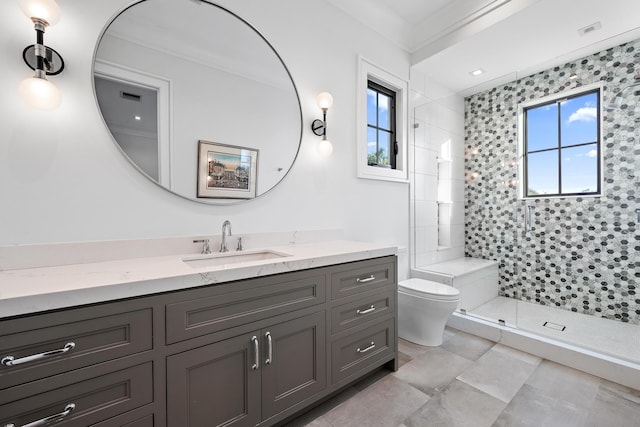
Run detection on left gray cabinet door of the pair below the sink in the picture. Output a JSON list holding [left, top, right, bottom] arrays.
[[167, 332, 260, 427]]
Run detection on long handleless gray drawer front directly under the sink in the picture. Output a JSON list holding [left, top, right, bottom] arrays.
[[166, 274, 326, 344]]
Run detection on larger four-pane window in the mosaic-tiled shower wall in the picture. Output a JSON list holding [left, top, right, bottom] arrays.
[[521, 87, 602, 198]]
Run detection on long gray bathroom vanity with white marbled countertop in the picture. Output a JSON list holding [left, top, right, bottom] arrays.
[[0, 242, 397, 427]]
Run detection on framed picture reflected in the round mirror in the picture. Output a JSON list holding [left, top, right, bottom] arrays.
[[198, 141, 258, 199]]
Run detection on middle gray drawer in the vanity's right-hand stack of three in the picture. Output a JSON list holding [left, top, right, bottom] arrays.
[[331, 289, 396, 334]]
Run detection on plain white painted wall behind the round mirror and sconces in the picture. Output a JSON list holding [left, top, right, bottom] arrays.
[[0, 0, 409, 276]]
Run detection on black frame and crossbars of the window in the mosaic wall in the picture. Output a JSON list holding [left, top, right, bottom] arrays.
[[522, 88, 602, 198]]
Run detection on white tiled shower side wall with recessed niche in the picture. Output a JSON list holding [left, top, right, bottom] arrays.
[[411, 70, 464, 267]]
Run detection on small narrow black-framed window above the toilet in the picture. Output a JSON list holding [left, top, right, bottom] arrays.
[[367, 81, 398, 169]]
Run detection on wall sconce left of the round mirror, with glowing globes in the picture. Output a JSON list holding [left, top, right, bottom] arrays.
[[20, 0, 64, 110]]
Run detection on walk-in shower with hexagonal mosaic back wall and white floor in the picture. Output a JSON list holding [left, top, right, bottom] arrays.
[[412, 40, 640, 387]]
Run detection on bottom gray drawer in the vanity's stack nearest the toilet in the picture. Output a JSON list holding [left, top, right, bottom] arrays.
[[331, 319, 396, 384]]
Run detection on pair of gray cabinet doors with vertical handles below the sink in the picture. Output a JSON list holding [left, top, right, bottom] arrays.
[[167, 311, 326, 426]]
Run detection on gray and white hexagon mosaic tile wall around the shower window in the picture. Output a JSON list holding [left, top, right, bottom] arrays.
[[465, 40, 640, 324]]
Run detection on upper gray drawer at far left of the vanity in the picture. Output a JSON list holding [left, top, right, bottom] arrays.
[[0, 307, 153, 390]]
